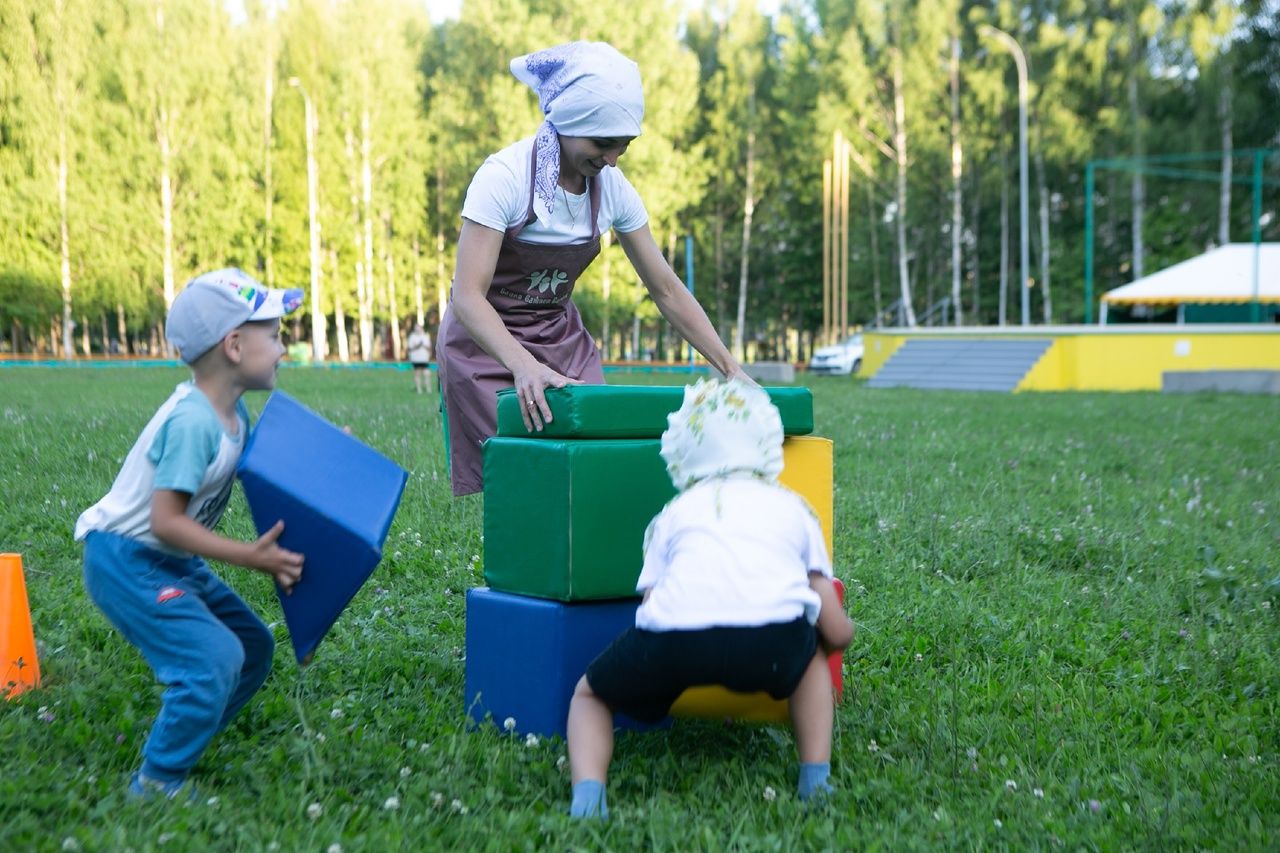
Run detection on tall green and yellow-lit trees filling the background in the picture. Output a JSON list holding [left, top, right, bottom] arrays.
[[0, 0, 1280, 350]]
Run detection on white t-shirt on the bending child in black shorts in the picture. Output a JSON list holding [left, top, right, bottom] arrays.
[[636, 476, 832, 631]]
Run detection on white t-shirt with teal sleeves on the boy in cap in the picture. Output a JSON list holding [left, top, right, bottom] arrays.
[[76, 382, 248, 556]]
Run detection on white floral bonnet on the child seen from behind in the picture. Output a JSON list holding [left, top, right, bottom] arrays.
[[662, 379, 782, 492]]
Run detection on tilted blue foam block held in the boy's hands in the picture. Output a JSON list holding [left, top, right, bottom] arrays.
[[237, 391, 408, 663]]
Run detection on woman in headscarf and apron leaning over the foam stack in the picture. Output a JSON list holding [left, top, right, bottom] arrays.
[[436, 41, 745, 496]]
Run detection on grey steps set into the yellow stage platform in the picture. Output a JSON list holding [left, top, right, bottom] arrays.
[[867, 338, 1053, 392]]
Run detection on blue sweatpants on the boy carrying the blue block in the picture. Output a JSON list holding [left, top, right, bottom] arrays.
[[84, 532, 275, 781]]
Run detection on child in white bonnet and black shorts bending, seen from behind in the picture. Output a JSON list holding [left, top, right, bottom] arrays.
[[568, 379, 854, 817]]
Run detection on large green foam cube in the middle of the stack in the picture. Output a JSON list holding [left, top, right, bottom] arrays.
[[484, 437, 676, 602]]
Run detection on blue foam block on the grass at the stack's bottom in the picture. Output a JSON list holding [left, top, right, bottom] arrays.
[[463, 587, 655, 738]]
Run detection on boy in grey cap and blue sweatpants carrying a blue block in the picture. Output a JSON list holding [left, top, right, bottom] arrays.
[[76, 269, 302, 799]]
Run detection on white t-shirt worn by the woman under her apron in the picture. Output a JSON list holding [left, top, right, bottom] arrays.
[[462, 137, 649, 245]]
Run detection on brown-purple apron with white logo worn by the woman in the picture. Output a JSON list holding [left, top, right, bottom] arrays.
[[436, 143, 604, 496]]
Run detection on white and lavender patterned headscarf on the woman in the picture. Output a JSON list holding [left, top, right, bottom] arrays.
[[511, 41, 644, 211]]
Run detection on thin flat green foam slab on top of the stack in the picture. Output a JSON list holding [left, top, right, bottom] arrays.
[[498, 386, 813, 439]]
